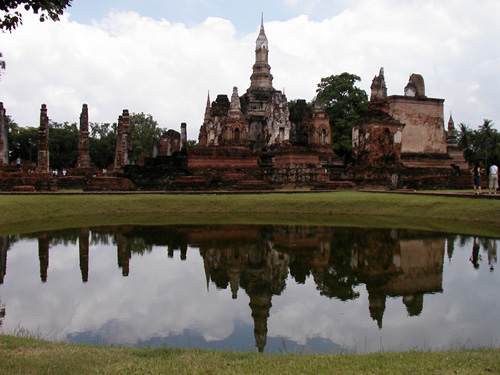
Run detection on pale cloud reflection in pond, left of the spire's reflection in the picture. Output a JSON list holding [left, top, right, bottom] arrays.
[[0, 243, 251, 344]]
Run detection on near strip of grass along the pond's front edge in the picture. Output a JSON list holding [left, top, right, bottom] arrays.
[[0, 336, 500, 375]]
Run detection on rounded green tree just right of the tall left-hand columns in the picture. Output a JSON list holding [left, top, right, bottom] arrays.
[[129, 112, 163, 162]]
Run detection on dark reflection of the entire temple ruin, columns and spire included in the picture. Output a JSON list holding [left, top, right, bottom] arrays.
[[0, 225, 478, 351]]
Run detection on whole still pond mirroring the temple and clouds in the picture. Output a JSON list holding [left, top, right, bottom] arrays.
[[0, 225, 500, 353]]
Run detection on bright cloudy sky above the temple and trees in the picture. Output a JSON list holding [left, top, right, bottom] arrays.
[[0, 0, 500, 139]]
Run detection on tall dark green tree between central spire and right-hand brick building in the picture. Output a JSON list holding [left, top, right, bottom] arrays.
[[315, 72, 368, 158]]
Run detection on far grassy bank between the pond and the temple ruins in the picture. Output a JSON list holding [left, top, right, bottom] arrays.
[[0, 192, 500, 236]]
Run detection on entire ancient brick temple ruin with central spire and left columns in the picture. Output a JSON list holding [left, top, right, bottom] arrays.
[[0, 20, 470, 191]]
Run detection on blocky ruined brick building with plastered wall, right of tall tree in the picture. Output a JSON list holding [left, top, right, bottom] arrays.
[[350, 68, 468, 188]]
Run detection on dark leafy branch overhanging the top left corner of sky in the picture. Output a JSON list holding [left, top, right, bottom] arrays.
[[0, 0, 72, 32]]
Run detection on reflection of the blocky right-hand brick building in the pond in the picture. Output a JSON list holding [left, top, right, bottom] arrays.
[[352, 230, 446, 328]]
